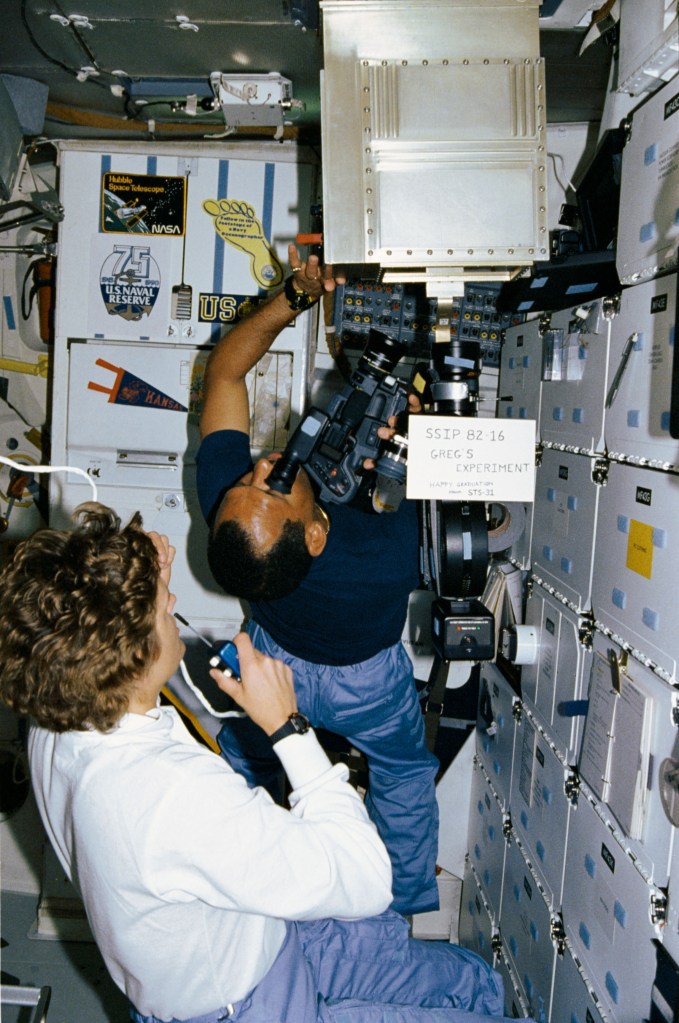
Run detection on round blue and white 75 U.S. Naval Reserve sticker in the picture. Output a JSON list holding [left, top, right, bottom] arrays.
[[99, 244, 161, 320]]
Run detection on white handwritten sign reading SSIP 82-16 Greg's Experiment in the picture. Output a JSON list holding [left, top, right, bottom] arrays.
[[406, 415, 535, 502]]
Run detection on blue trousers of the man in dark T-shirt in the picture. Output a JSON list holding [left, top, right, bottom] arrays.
[[218, 622, 439, 916]]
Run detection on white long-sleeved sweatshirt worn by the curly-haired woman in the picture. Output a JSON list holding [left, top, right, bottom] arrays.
[[29, 707, 392, 1019]]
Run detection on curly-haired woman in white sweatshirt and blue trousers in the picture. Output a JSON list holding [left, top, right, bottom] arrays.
[[0, 503, 523, 1023]]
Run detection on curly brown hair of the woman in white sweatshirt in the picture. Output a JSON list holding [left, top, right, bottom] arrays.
[[0, 501, 160, 731]]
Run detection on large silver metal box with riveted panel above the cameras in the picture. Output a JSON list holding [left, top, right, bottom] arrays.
[[321, 0, 548, 279]]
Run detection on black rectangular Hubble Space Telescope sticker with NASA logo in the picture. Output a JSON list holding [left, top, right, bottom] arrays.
[[100, 171, 186, 235]]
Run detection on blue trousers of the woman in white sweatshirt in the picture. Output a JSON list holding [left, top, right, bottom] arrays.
[[132, 909, 531, 1023]]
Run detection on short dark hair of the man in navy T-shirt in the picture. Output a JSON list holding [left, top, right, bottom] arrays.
[[208, 519, 313, 601]]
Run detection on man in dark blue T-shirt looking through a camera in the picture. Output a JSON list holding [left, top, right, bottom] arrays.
[[197, 246, 438, 915]]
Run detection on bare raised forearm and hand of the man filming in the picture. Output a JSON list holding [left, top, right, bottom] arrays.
[[200, 244, 344, 437]]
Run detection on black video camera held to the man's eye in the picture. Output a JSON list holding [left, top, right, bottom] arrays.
[[267, 328, 408, 504]]
